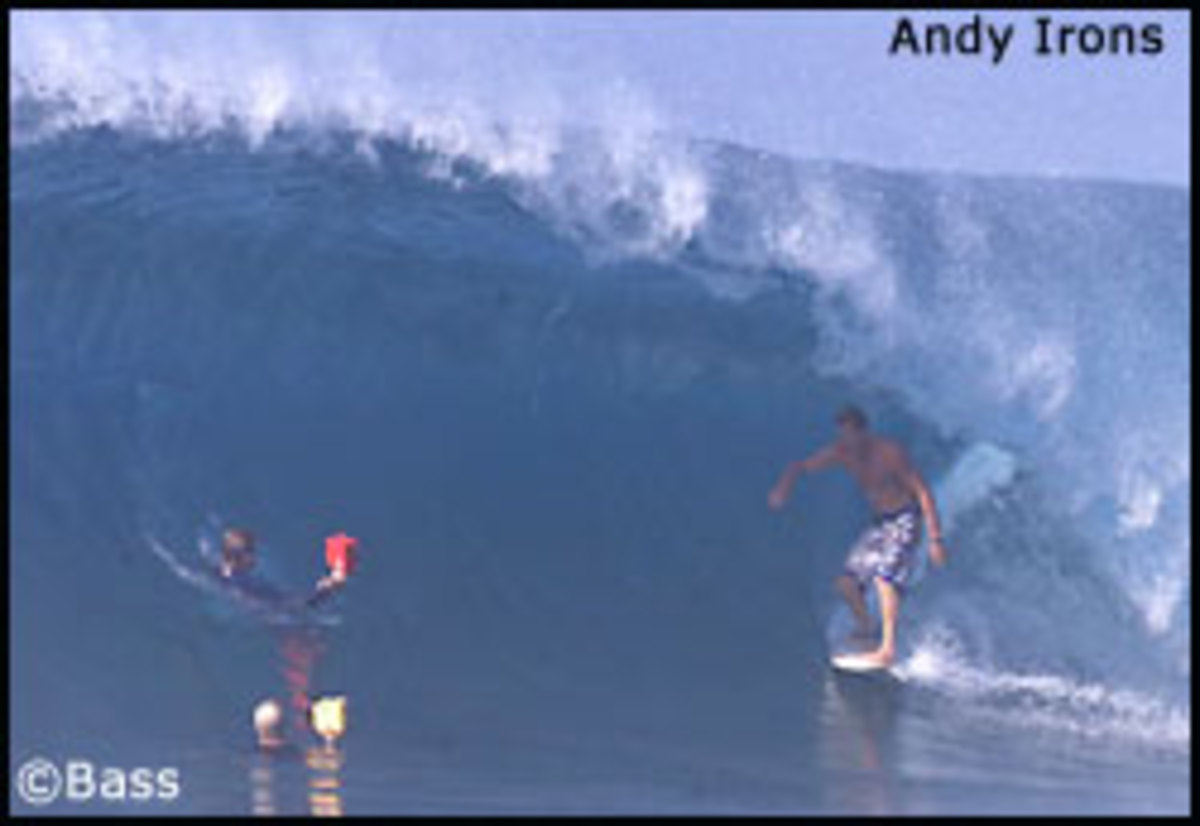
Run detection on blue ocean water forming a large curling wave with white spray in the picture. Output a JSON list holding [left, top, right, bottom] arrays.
[[10, 19, 1190, 814]]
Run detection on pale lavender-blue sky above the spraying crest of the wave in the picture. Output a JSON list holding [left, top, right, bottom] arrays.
[[11, 11, 1190, 185]]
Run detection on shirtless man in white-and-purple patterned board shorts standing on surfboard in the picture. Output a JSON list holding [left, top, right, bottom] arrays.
[[767, 406, 946, 666]]
